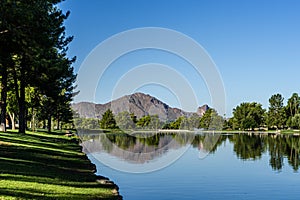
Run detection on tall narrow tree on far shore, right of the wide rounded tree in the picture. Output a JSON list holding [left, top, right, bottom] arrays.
[[267, 94, 285, 129]]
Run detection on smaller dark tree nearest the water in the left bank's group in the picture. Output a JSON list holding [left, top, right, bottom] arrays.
[[39, 54, 76, 132]]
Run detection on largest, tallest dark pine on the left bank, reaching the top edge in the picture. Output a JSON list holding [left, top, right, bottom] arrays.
[[0, 0, 73, 133]]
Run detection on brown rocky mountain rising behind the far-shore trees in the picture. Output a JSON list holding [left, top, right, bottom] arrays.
[[72, 93, 209, 121]]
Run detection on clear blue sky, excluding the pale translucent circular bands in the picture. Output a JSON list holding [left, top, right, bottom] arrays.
[[60, 0, 300, 116]]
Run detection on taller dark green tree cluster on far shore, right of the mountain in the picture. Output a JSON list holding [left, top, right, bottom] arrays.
[[225, 93, 300, 130]]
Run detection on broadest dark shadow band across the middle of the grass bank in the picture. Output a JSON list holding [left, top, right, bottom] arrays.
[[0, 141, 95, 181]]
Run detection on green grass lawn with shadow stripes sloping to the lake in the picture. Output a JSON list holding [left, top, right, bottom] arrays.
[[0, 132, 120, 200]]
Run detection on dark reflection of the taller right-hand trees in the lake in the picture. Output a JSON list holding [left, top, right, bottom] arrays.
[[229, 134, 300, 171]]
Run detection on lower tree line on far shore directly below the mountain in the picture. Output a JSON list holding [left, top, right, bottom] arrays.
[[74, 108, 224, 130]]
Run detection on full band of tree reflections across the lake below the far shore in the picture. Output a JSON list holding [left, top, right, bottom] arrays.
[[81, 133, 300, 172]]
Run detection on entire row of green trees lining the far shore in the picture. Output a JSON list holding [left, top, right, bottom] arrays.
[[75, 93, 300, 130]]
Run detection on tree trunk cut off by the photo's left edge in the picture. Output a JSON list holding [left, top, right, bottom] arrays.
[[0, 67, 7, 132]]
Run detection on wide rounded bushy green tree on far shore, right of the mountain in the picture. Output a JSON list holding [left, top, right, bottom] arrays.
[[233, 102, 265, 130]]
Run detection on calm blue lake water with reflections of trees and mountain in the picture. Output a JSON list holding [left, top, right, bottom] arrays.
[[79, 134, 300, 200]]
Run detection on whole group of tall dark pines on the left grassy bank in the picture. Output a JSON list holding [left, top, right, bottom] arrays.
[[0, 0, 76, 133]]
